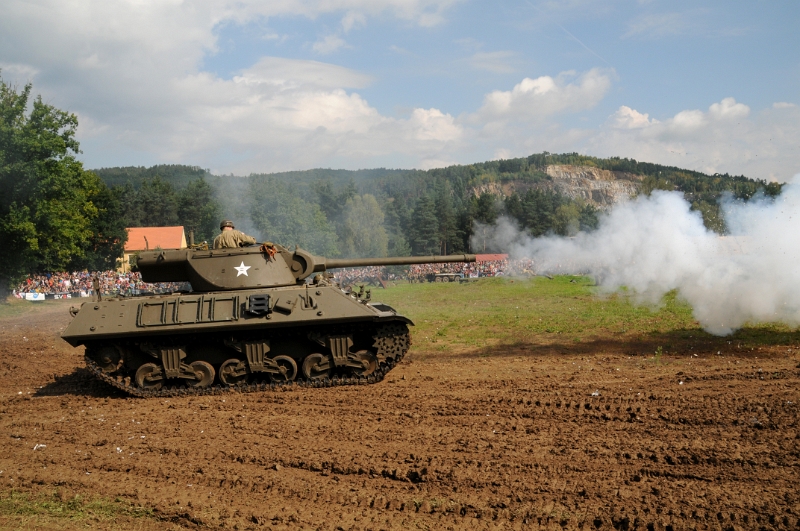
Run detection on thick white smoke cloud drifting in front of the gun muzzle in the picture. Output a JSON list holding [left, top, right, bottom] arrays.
[[474, 180, 800, 335]]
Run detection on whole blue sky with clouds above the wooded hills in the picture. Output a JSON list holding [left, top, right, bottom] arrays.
[[0, 0, 800, 182]]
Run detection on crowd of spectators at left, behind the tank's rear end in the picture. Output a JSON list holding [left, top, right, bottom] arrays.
[[13, 271, 186, 298]]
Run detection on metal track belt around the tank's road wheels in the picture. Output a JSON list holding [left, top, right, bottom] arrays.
[[84, 324, 411, 398]]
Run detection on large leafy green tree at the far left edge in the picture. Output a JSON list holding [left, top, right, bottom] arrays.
[[0, 78, 117, 300]]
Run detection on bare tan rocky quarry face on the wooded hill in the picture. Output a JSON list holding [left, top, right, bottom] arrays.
[[475, 165, 644, 209]]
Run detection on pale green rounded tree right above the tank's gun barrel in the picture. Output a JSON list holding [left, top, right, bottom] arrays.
[[342, 194, 389, 257]]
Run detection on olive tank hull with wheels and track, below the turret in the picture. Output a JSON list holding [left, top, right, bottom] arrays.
[[62, 284, 413, 396]]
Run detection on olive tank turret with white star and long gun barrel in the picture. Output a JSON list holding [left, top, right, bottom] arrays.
[[137, 244, 475, 292]]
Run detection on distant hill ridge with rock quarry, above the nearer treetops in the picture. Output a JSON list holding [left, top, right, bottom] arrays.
[[92, 152, 780, 208]]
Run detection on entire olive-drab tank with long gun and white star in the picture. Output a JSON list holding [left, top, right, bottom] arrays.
[[61, 244, 475, 397]]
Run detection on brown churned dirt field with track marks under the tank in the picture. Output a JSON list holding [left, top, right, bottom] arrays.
[[0, 303, 800, 530]]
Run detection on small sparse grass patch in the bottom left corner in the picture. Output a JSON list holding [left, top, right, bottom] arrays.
[[0, 490, 154, 521]]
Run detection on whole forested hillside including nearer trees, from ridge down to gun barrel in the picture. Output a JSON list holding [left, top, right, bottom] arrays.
[[90, 153, 781, 256]]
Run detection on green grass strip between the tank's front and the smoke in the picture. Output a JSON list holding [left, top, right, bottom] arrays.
[[373, 276, 800, 361]]
